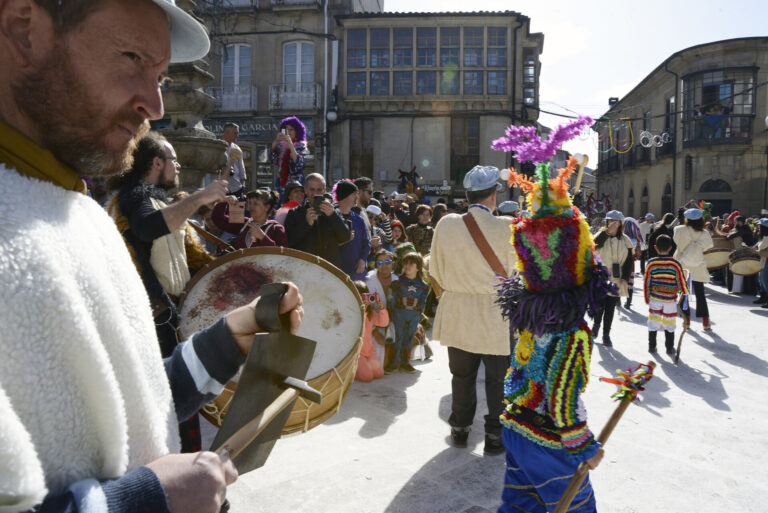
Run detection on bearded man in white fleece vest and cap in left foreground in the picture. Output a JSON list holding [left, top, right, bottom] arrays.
[[0, 0, 302, 513]]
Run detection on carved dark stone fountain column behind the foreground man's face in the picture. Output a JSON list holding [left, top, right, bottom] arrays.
[[160, 0, 227, 192]]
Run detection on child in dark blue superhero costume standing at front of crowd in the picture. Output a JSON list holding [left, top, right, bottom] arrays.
[[384, 252, 429, 373]]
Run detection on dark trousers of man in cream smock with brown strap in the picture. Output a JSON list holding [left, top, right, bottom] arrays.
[[448, 347, 509, 436]]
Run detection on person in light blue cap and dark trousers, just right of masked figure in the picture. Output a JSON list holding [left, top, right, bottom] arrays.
[[592, 210, 635, 347]]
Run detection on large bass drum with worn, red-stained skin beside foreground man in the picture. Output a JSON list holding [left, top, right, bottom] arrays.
[[179, 247, 364, 434]]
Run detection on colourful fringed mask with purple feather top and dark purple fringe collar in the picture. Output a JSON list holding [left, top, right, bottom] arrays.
[[492, 117, 611, 335]]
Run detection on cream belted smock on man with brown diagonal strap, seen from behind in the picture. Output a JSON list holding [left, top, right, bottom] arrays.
[[429, 208, 516, 355]]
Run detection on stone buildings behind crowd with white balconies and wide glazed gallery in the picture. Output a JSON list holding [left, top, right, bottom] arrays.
[[197, 0, 544, 196]]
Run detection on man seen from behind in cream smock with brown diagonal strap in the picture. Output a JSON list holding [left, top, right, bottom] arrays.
[[429, 166, 515, 454]]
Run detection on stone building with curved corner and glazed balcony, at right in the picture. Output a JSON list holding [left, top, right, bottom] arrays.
[[596, 37, 768, 218]]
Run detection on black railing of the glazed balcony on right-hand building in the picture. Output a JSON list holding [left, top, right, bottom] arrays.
[[683, 114, 754, 148]]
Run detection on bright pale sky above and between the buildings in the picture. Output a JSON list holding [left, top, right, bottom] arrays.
[[384, 0, 768, 167]]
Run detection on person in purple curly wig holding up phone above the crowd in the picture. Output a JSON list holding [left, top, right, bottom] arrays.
[[271, 116, 307, 201]]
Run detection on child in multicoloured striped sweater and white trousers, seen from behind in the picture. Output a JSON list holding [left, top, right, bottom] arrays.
[[643, 235, 688, 354]]
